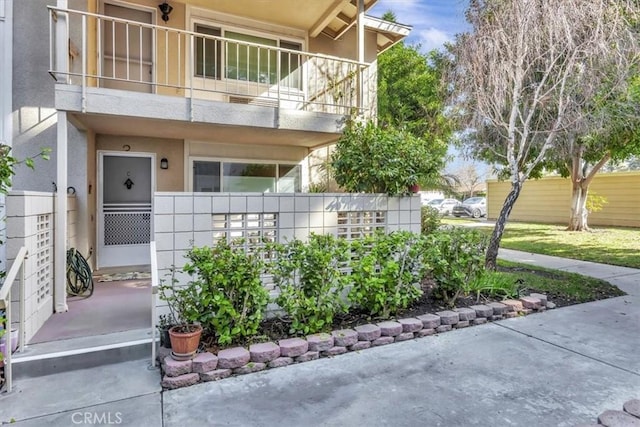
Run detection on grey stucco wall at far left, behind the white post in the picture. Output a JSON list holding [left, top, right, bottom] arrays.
[[11, 0, 89, 253]]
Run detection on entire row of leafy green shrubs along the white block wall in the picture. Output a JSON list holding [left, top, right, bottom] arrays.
[[160, 228, 492, 345]]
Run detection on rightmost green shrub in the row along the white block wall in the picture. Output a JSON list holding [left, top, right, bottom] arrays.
[[427, 227, 488, 306]]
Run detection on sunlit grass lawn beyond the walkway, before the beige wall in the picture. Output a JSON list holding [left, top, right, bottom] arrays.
[[442, 218, 640, 268]]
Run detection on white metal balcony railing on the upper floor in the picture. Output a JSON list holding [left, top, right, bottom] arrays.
[[49, 7, 376, 114]]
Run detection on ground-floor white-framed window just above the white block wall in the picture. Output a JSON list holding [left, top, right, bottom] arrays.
[[193, 160, 302, 193]]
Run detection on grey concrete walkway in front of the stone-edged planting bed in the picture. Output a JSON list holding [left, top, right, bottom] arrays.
[[0, 251, 640, 426]]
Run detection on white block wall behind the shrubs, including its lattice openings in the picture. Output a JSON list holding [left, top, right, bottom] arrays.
[[153, 192, 421, 314]]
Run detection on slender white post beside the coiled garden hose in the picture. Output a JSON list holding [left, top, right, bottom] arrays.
[[53, 111, 69, 313]]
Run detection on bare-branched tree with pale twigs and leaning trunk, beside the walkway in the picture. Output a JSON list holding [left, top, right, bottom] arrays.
[[451, 0, 637, 268]]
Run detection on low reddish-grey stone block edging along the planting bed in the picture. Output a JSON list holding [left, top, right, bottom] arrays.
[[158, 294, 553, 389]]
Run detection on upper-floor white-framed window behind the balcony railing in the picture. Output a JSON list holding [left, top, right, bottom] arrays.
[[193, 23, 302, 90]]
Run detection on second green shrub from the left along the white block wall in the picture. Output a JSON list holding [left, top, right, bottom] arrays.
[[270, 234, 349, 334]]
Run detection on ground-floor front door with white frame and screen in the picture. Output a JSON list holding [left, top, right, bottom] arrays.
[[97, 152, 155, 268]]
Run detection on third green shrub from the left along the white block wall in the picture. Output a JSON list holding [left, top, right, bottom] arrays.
[[349, 231, 426, 318]]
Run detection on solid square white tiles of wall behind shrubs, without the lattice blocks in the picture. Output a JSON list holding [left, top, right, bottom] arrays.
[[154, 193, 420, 305]]
